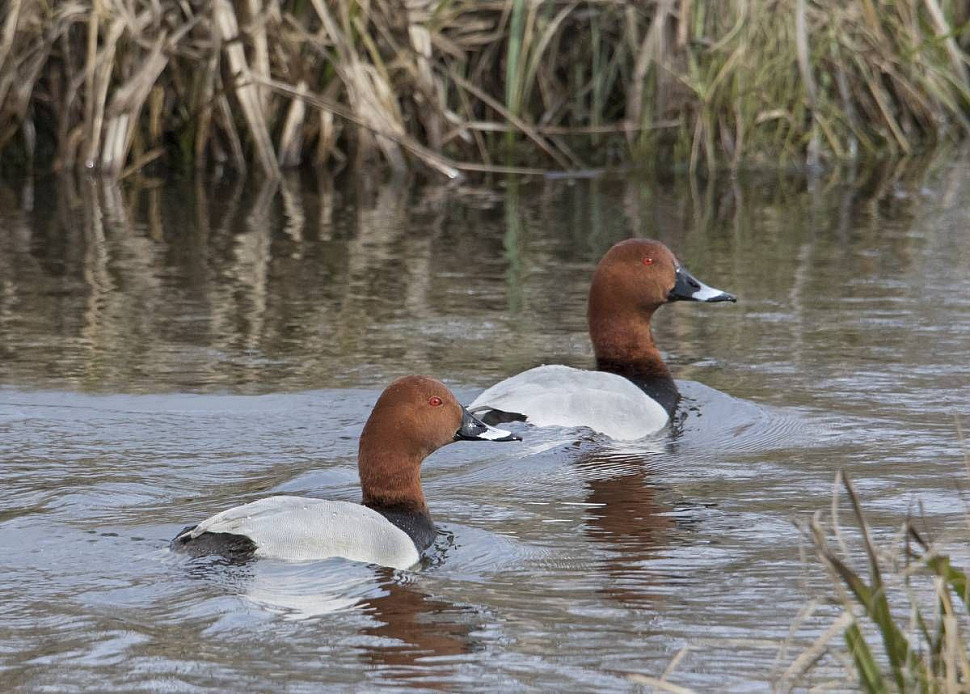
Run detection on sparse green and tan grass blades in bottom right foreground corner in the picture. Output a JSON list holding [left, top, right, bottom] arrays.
[[777, 467, 970, 694]]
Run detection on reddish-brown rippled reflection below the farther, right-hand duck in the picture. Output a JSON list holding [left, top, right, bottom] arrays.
[[574, 451, 676, 606]]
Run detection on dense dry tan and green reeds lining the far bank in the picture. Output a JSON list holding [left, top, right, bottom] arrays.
[[0, 0, 970, 177]]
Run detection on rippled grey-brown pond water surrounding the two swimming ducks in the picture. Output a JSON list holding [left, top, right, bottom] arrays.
[[0, 162, 970, 691]]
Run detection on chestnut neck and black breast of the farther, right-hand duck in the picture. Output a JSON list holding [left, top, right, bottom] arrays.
[[589, 301, 679, 413]]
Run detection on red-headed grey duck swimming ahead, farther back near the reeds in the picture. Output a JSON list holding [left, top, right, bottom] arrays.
[[469, 238, 737, 440]]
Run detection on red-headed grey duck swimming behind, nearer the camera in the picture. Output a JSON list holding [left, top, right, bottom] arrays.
[[170, 376, 521, 569]]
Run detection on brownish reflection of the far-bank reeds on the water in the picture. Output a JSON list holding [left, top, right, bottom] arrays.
[[0, 157, 959, 391]]
